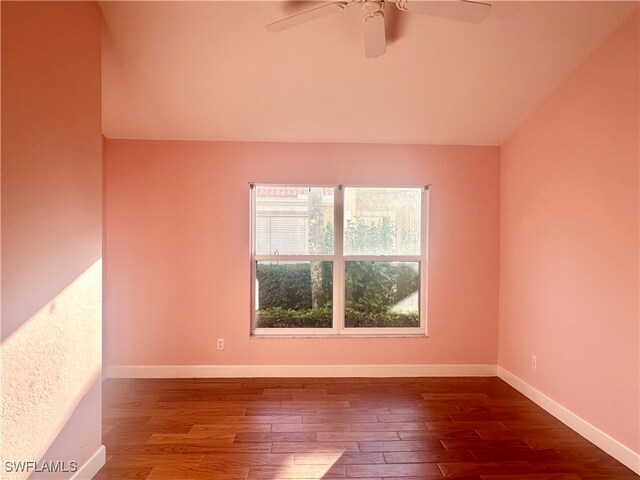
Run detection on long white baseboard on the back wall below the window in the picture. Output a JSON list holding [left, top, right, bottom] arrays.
[[105, 365, 496, 378]]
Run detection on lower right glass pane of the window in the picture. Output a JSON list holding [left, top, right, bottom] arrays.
[[345, 262, 420, 328]]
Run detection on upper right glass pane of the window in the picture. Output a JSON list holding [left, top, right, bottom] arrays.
[[344, 187, 422, 255]]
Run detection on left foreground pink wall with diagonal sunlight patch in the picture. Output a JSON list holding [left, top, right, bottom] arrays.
[[0, 1, 102, 478]]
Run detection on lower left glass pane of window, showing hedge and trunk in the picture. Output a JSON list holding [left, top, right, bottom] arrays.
[[255, 262, 333, 328]]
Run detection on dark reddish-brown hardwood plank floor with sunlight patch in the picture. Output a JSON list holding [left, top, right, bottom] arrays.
[[95, 378, 639, 480]]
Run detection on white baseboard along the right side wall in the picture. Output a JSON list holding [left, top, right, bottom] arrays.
[[497, 366, 640, 475]]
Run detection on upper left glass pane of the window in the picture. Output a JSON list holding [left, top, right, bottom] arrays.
[[255, 185, 334, 255]]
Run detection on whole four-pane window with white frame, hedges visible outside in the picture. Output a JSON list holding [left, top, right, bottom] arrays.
[[251, 185, 428, 335]]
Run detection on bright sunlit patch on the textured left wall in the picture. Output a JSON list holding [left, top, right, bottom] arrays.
[[0, 259, 102, 479]]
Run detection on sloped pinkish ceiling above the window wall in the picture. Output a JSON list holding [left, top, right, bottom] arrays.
[[101, 0, 638, 145]]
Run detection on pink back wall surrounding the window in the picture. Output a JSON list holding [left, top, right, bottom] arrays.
[[104, 140, 499, 365]]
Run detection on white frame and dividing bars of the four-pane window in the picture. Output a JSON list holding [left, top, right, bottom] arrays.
[[249, 183, 431, 337]]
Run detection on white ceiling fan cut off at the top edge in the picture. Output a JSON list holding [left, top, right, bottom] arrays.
[[265, 0, 491, 58]]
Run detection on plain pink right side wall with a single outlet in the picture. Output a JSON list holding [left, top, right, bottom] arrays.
[[499, 10, 640, 452]]
